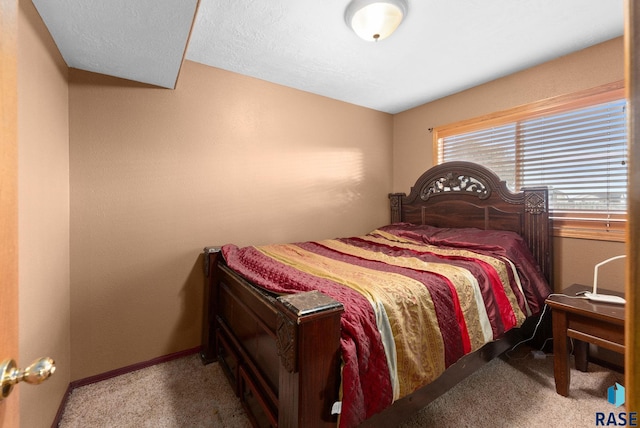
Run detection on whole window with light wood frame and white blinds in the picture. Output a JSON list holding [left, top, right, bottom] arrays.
[[434, 82, 628, 241]]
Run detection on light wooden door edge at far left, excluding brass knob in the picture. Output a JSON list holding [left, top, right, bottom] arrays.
[[0, 0, 20, 428]]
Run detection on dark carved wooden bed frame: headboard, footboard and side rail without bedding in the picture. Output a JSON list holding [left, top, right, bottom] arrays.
[[201, 162, 552, 428]]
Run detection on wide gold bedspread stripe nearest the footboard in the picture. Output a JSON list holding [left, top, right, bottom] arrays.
[[258, 241, 445, 399]]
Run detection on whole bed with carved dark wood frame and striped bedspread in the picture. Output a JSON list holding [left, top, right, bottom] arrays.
[[201, 162, 552, 427]]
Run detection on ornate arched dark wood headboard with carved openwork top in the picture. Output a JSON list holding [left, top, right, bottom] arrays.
[[389, 161, 553, 285]]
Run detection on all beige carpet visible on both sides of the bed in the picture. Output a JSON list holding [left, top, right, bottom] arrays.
[[59, 348, 624, 428]]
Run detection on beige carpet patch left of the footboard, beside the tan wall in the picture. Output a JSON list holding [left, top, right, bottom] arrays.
[[58, 354, 251, 428]]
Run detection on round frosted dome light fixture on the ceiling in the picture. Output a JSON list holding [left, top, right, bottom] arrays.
[[344, 0, 407, 42]]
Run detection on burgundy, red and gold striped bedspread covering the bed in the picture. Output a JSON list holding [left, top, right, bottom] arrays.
[[222, 223, 551, 427]]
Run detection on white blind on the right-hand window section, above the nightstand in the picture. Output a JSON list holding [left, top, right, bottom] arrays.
[[519, 100, 627, 213]]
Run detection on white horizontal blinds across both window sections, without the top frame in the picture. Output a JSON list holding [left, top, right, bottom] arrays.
[[438, 100, 628, 241]]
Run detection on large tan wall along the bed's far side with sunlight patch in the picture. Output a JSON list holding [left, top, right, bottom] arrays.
[[70, 62, 392, 379]]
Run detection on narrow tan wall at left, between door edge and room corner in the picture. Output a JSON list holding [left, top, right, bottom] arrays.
[[18, 0, 71, 427]]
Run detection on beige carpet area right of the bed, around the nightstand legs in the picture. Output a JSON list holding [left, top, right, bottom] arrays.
[[402, 349, 625, 428]]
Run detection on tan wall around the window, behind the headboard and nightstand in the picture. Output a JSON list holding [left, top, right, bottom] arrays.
[[393, 37, 625, 291]]
